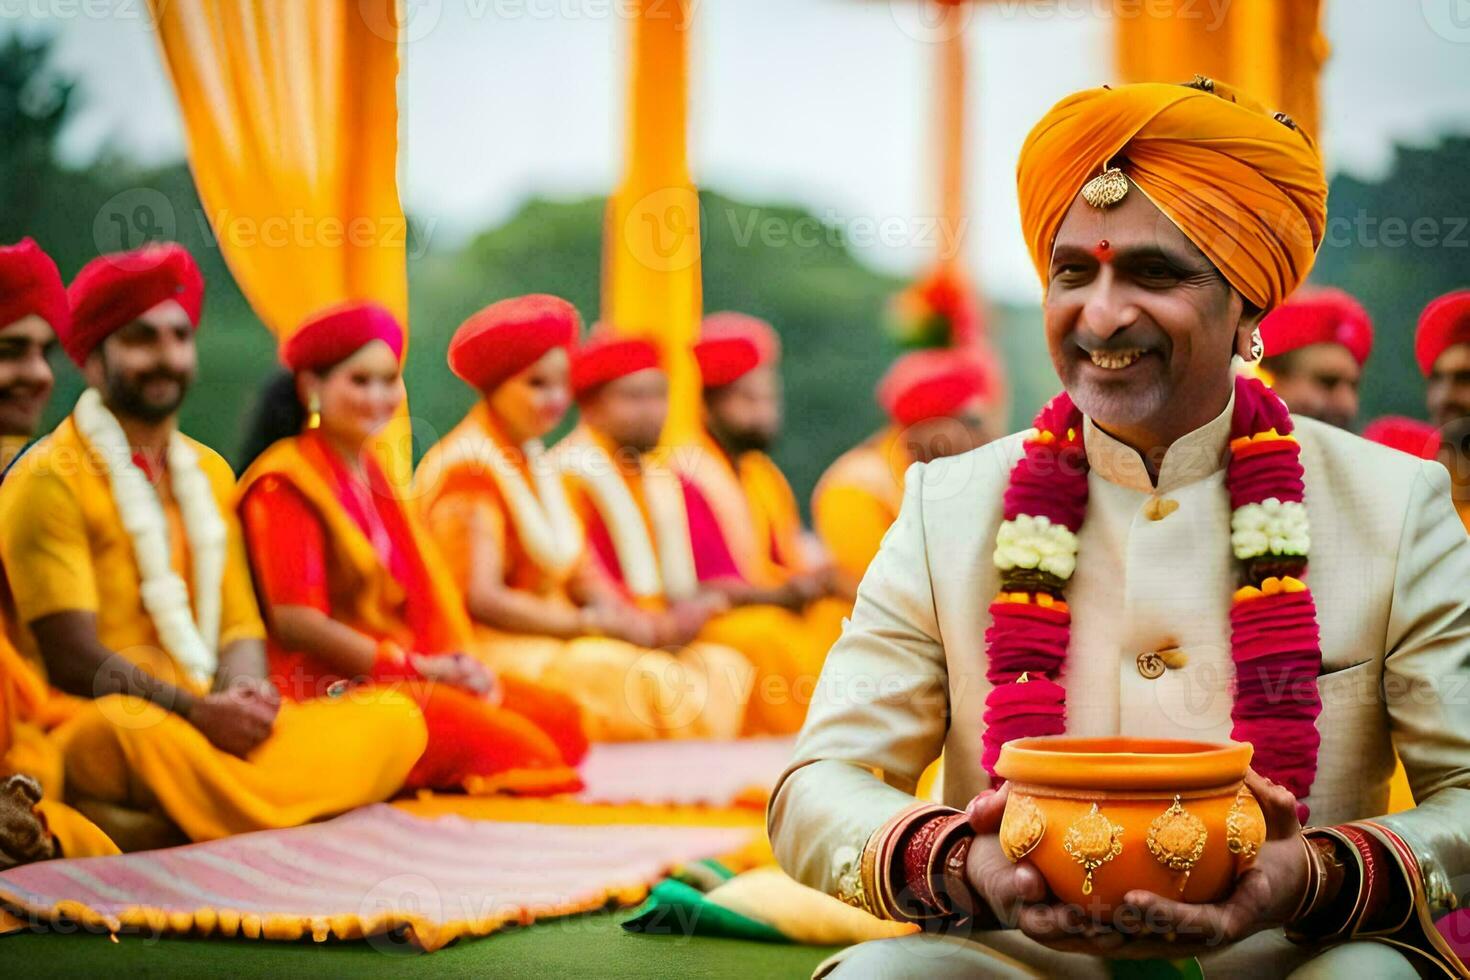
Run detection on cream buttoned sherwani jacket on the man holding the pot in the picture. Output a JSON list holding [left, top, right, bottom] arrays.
[[769, 396, 1470, 964]]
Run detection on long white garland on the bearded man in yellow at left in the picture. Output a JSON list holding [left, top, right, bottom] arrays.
[[74, 388, 228, 685]]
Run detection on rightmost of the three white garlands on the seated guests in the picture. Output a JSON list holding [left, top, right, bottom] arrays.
[[556, 439, 700, 601]]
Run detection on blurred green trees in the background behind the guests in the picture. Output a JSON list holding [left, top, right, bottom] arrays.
[[0, 34, 1470, 501]]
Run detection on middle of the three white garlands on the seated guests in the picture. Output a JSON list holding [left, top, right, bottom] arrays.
[[442, 433, 585, 579]]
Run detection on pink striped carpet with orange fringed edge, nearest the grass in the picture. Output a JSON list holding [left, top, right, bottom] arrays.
[[0, 805, 754, 949]]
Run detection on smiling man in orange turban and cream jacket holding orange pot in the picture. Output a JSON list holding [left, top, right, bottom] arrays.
[[769, 79, 1470, 977]]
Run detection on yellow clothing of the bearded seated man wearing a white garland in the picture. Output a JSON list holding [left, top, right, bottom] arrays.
[[0, 419, 426, 840]]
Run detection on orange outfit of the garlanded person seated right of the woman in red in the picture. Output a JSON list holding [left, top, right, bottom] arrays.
[[416, 403, 750, 741]]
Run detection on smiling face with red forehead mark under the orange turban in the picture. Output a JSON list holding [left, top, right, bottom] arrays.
[[1045, 188, 1260, 445]]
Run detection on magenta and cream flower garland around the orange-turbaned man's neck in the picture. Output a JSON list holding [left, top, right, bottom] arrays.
[[980, 378, 1322, 799]]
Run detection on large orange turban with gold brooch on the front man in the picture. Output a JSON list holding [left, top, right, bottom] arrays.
[[1016, 82, 1327, 311]]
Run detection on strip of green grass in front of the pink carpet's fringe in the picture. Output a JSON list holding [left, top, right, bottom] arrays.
[[0, 909, 833, 980]]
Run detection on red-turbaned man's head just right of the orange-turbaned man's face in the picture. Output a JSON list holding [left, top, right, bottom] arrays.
[[1261, 288, 1373, 430]]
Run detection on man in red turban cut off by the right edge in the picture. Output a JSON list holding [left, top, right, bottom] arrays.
[[1414, 289, 1470, 530]]
